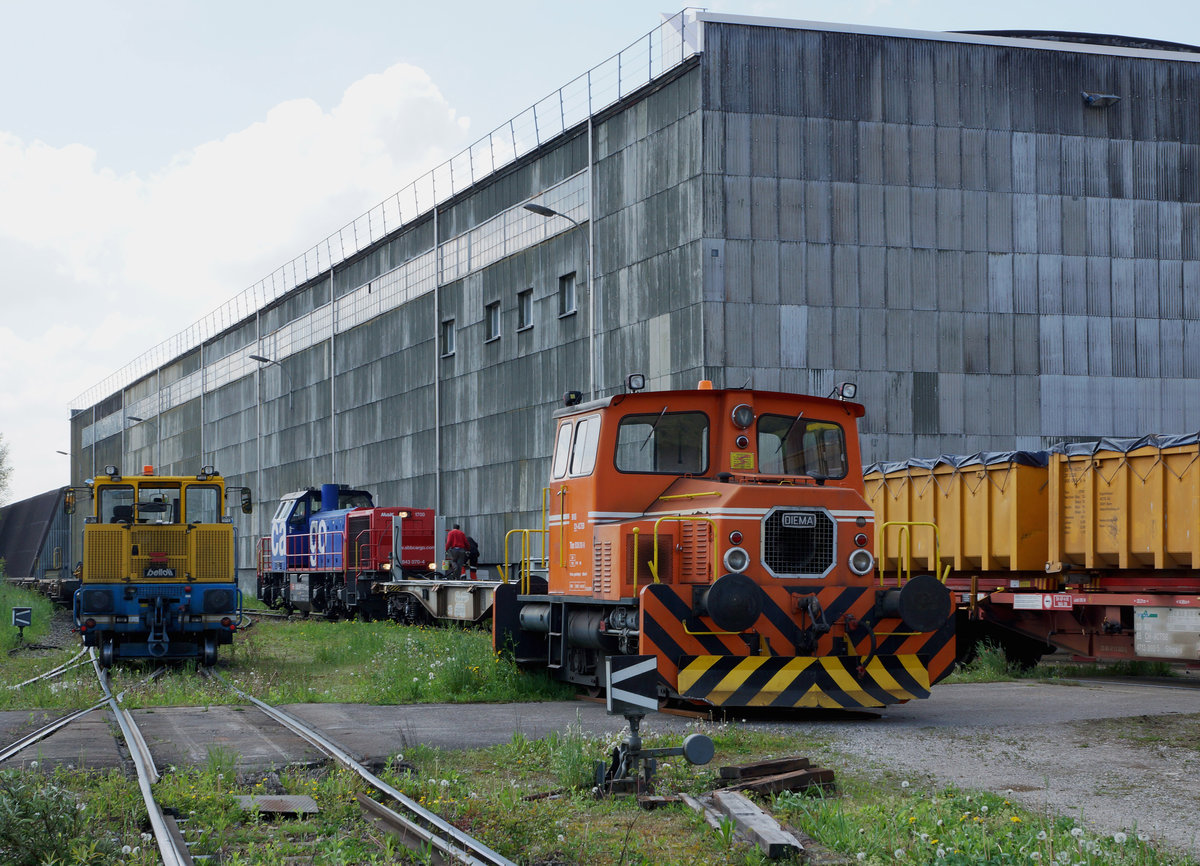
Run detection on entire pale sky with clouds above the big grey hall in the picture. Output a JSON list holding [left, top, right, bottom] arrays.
[[0, 0, 1200, 501]]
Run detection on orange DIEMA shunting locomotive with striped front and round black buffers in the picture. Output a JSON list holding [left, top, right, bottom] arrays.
[[493, 377, 954, 708]]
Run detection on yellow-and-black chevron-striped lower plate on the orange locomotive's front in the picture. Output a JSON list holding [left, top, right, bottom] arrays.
[[678, 655, 929, 709]]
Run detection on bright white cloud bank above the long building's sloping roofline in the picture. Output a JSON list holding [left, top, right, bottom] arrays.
[[0, 64, 469, 499]]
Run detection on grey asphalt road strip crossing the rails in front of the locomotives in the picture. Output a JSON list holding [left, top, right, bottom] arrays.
[[0, 681, 1200, 772]]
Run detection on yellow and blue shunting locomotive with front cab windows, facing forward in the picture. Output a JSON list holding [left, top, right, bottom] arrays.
[[67, 465, 251, 667]]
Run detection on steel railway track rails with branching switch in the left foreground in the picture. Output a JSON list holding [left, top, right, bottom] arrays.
[[0, 650, 515, 866]]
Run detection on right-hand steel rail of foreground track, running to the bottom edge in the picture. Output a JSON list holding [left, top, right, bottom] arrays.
[[206, 670, 516, 866]]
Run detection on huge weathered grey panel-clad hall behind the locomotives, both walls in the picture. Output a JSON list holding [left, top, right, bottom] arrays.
[[71, 12, 1200, 580]]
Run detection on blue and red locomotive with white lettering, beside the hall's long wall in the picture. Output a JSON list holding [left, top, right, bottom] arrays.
[[258, 485, 434, 619]]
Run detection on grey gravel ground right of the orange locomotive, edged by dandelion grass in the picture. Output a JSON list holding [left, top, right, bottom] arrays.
[[796, 682, 1200, 859]]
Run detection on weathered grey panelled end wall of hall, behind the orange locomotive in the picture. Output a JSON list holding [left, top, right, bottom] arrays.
[[702, 23, 1200, 458]]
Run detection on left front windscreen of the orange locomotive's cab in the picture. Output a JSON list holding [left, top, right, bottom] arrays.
[[616, 407, 708, 475]]
